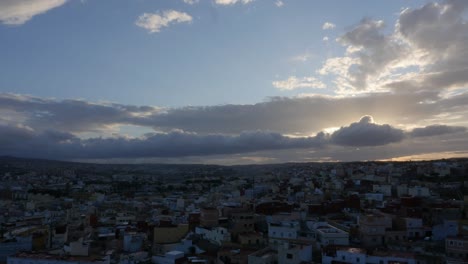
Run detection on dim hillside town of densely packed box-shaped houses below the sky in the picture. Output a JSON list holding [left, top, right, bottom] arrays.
[[0, 157, 468, 264]]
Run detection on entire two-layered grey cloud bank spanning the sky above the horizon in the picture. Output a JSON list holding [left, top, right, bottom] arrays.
[[0, 92, 468, 162]]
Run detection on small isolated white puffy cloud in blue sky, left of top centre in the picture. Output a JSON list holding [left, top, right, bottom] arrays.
[[135, 10, 192, 33]]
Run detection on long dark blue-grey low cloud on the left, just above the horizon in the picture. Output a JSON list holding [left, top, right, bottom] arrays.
[[0, 126, 326, 159]]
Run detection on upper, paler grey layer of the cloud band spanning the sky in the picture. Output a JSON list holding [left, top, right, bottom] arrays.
[[5, 89, 468, 135]]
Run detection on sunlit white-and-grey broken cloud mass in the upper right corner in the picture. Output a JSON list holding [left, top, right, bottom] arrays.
[[318, 0, 468, 94]]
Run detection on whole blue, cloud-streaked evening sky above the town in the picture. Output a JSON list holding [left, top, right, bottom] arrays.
[[0, 0, 468, 165]]
